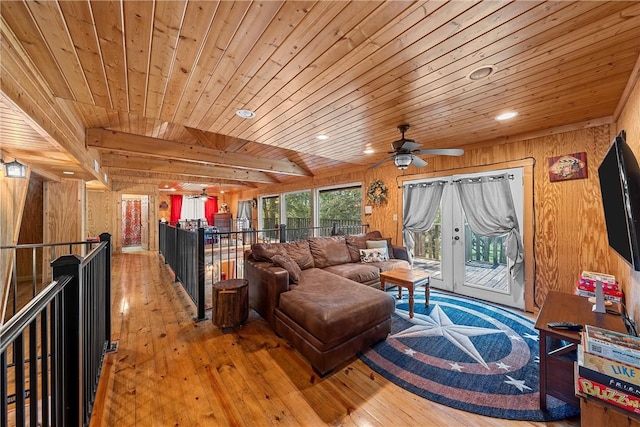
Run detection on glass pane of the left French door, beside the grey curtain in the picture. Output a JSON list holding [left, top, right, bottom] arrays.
[[412, 206, 442, 279]]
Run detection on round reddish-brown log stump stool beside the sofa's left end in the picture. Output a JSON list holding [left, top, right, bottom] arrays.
[[211, 279, 249, 329]]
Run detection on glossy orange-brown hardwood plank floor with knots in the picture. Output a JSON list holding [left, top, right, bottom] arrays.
[[90, 252, 579, 427]]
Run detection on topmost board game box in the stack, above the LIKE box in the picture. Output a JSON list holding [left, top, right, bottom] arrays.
[[582, 325, 640, 367]]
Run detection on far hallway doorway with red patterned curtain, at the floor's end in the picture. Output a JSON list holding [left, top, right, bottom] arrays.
[[120, 194, 149, 252]]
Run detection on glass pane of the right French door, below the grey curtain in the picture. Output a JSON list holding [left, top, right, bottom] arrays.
[[464, 220, 509, 292]]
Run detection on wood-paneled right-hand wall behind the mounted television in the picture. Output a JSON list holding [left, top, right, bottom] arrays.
[[609, 67, 640, 323]]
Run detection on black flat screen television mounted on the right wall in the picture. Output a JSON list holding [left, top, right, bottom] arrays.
[[598, 131, 640, 271]]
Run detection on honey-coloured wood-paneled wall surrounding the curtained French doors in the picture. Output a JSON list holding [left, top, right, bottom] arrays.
[[258, 125, 615, 312]]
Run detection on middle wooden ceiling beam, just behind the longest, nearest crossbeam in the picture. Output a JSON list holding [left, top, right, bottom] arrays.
[[102, 153, 278, 184]]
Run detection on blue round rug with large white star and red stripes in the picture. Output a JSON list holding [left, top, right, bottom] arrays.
[[360, 289, 580, 421]]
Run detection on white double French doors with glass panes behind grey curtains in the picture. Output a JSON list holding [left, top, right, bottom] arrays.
[[411, 168, 525, 309]]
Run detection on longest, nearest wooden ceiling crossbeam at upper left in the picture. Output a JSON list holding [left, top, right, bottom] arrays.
[[86, 128, 310, 176]]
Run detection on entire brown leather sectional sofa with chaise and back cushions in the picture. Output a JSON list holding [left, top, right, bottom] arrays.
[[245, 231, 409, 376]]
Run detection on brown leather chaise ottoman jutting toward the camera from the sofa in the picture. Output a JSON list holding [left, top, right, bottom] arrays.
[[274, 268, 395, 376]]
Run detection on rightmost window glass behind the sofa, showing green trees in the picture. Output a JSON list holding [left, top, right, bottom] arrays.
[[318, 186, 362, 236]]
